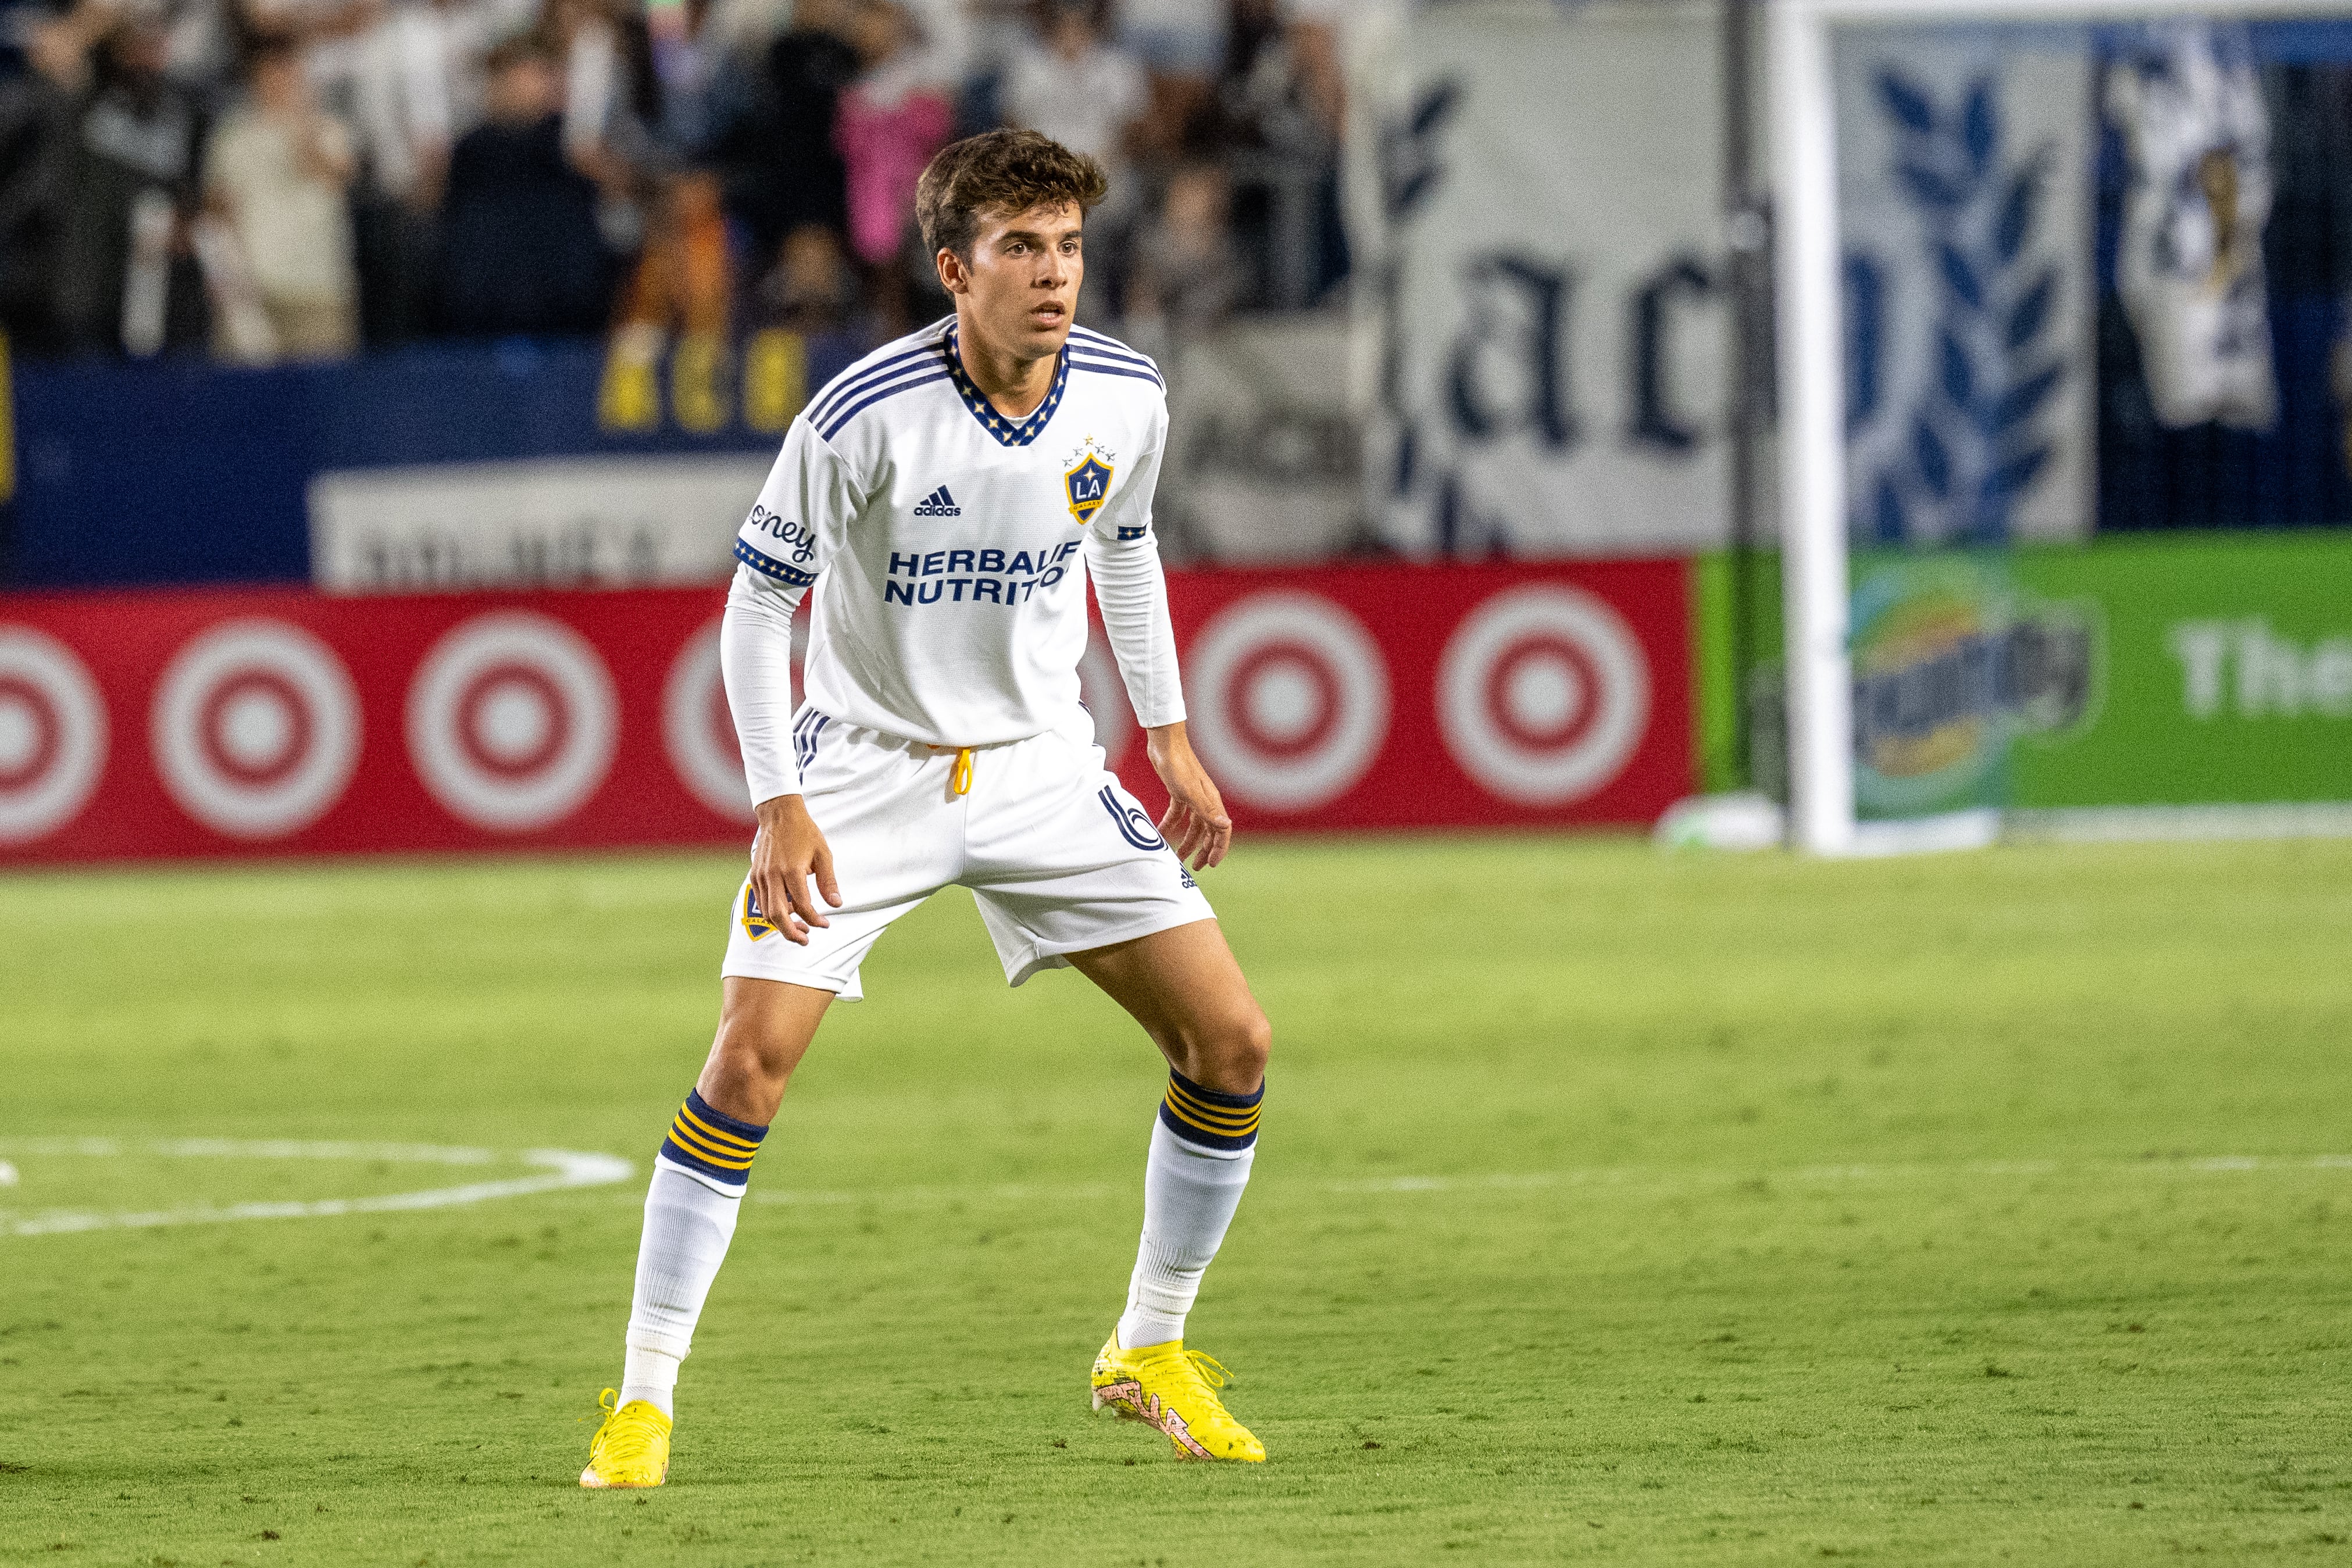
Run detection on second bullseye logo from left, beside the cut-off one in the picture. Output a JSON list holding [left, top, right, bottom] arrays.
[[148, 618, 360, 840]]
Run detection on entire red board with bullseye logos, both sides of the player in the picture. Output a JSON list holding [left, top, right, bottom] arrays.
[[0, 562, 1691, 863]]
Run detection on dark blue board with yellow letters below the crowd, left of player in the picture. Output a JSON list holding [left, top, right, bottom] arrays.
[[0, 334, 858, 588]]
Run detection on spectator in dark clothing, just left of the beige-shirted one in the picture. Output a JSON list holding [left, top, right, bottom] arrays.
[[49, 21, 205, 355]]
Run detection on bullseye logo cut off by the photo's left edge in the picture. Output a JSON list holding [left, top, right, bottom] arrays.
[[0, 626, 106, 844]]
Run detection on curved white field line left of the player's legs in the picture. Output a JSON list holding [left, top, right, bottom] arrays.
[[0, 1138, 635, 1237]]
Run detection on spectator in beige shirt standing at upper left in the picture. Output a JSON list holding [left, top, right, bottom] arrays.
[[200, 40, 360, 365]]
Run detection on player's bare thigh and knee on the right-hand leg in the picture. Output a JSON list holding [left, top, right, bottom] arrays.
[[1068, 919, 1272, 1093]]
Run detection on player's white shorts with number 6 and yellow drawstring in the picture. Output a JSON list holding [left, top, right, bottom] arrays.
[[720, 708, 1214, 1002]]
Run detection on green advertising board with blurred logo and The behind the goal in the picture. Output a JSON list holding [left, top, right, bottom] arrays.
[[1693, 531, 2352, 830]]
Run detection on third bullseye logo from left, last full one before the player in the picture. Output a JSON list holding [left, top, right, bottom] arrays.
[[409, 611, 621, 832]]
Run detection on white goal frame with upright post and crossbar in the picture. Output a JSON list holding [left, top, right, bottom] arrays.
[[1766, 0, 2352, 856]]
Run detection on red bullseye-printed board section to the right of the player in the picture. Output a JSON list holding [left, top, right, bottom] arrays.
[[1138, 562, 1691, 827]]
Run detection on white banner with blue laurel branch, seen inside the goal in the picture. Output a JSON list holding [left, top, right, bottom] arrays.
[[1837, 28, 2098, 545]]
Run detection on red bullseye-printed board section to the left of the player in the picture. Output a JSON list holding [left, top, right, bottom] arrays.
[[0, 590, 748, 860]]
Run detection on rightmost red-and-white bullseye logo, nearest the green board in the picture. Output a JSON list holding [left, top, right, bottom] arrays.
[[1437, 583, 1649, 806]]
